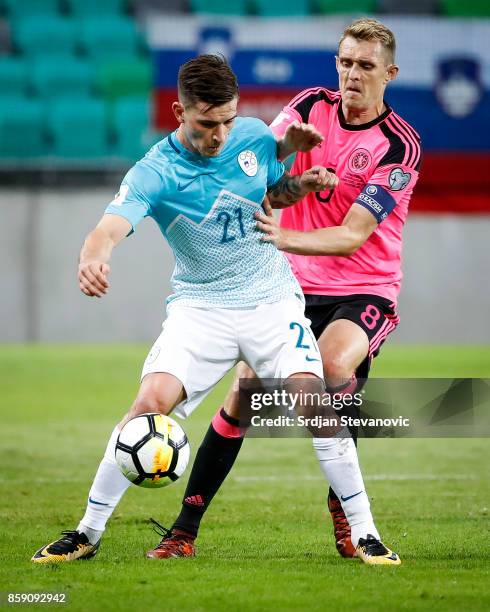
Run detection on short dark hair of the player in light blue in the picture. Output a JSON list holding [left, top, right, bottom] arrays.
[[177, 55, 239, 108]]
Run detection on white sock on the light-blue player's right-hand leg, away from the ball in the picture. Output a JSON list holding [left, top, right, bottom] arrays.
[[313, 437, 379, 546]]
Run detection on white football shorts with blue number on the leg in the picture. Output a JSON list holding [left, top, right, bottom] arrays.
[[141, 297, 323, 418]]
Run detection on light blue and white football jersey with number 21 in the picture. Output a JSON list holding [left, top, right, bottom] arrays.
[[106, 118, 302, 308]]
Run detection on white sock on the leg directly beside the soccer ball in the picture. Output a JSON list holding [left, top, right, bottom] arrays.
[[77, 427, 131, 544]]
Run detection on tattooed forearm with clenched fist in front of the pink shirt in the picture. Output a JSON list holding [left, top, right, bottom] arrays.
[[267, 166, 339, 208]]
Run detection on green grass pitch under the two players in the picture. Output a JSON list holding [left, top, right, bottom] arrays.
[[0, 345, 490, 611]]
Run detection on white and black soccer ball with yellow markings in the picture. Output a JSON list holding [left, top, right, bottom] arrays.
[[116, 413, 190, 489]]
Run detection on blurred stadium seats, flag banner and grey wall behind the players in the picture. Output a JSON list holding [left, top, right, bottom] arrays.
[[0, 0, 490, 343]]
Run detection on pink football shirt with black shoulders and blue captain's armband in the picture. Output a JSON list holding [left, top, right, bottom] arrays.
[[271, 87, 420, 304]]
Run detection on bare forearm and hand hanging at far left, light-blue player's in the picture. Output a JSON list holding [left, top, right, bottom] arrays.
[[78, 215, 131, 297]]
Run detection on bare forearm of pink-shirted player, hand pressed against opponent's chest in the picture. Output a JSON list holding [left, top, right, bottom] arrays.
[[255, 202, 378, 256]]
